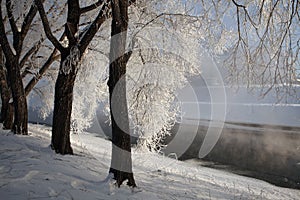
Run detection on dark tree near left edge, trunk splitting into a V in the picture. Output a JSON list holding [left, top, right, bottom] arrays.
[[0, 0, 42, 134]]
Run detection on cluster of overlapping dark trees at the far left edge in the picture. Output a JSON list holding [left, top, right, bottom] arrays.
[[0, 1, 65, 134]]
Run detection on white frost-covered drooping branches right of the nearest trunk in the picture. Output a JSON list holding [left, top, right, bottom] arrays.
[[128, 0, 300, 151]]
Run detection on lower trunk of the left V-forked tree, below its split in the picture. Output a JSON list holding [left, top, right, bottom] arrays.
[[6, 57, 28, 135]]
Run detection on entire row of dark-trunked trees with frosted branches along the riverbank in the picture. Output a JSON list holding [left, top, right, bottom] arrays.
[[0, 0, 300, 186]]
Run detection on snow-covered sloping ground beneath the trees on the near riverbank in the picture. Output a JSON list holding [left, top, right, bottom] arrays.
[[0, 125, 300, 200]]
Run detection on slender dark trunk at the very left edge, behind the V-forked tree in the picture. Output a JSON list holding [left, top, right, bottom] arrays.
[[0, 47, 14, 129]]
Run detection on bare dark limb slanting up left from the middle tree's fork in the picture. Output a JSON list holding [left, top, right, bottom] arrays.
[[34, 0, 64, 52]]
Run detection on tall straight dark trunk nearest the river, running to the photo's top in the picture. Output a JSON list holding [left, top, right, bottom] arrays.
[[108, 0, 136, 187]]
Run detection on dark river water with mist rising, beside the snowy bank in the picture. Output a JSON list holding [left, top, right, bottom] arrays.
[[165, 123, 300, 189]]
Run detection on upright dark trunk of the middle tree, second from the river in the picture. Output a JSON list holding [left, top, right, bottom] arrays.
[[52, 0, 82, 154]]
